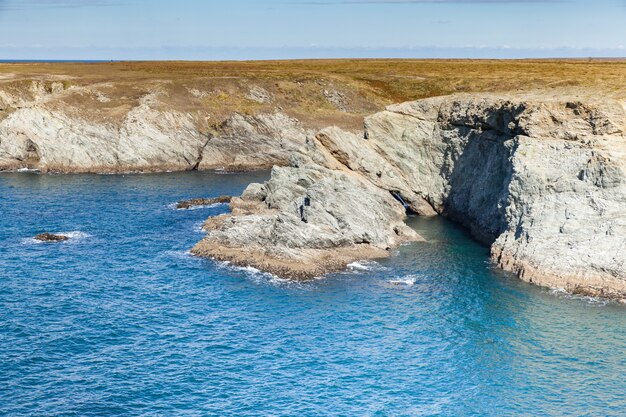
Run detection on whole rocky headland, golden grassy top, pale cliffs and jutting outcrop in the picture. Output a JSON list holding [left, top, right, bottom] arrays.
[[0, 61, 626, 299]]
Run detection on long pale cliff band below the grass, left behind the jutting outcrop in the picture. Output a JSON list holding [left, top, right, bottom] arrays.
[[0, 83, 307, 172]]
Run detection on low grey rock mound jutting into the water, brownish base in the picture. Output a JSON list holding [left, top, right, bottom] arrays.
[[192, 161, 421, 278]]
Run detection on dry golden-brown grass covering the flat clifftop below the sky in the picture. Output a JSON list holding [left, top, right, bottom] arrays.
[[0, 60, 626, 128]]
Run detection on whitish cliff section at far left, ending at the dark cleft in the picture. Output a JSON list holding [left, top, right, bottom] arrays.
[[0, 96, 206, 172]]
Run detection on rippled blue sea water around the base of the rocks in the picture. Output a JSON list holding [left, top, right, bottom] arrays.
[[0, 173, 626, 416]]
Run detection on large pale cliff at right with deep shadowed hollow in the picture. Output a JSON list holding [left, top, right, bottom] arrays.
[[356, 97, 626, 298]]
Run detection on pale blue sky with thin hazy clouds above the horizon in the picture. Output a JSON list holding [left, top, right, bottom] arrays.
[[0, 0, 626, 60]]
